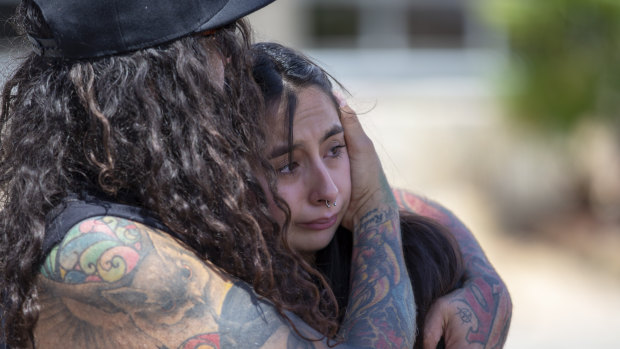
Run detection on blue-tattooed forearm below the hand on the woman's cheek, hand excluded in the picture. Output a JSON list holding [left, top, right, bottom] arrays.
[[342, 208, 415, 348]]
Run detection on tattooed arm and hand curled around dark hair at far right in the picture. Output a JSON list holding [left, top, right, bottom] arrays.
[[394, 189, 512, 349]]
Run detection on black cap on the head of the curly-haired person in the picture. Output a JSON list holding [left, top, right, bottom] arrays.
[[29, 0, 274, 59]]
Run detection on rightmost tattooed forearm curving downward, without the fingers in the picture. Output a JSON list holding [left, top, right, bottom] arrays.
[[394, 190, 512, 348]]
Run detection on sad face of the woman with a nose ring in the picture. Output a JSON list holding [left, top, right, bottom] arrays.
[[268, 87, 351, 255]]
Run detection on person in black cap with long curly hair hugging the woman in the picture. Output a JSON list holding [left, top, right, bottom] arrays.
[[0, 0, 415, 348]]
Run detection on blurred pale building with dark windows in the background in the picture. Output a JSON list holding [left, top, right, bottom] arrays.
[[249, 0, 503, 96]]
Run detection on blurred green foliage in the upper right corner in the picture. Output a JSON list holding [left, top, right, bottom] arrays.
[[480, 0, 620, 131]]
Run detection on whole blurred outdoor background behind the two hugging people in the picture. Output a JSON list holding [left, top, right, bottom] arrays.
[[0, 0, 620, 349]]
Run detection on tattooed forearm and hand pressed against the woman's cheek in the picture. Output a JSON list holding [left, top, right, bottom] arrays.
[[340, 101, 416, 348]]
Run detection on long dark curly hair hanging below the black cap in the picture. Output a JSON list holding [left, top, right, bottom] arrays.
[[0, 0, 337, 347]]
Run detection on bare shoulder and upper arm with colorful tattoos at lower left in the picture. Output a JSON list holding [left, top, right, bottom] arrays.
[[35, 216, 332, 349]]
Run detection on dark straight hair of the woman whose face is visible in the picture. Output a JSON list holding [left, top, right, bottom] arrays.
[[252, 42, 464, 348]]
